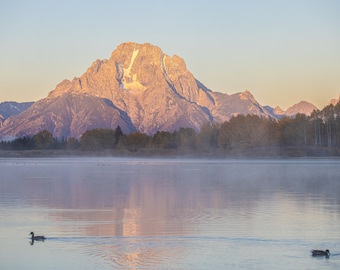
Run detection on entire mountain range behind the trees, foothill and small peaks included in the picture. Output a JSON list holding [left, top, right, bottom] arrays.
[[0, 42, 330, 139]]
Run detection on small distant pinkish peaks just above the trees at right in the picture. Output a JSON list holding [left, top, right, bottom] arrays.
[[265, 101, 318, 119]]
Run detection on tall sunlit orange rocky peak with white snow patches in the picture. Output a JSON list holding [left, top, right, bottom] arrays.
[[48, 43, 218, 133]]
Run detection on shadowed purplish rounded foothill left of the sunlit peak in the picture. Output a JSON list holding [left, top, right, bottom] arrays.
[[1, 93, 136, 138]]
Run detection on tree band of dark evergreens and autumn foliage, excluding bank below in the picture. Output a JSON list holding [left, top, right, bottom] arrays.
[[0, 103, 340, 156]]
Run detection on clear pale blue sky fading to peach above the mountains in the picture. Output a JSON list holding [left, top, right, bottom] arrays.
[[0, 0, 340, 109]]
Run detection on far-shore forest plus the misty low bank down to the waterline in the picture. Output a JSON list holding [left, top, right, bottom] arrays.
[[0, 103, 340, 157]]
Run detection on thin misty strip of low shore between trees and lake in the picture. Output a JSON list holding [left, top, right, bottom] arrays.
[[0, 147, 340, 159]]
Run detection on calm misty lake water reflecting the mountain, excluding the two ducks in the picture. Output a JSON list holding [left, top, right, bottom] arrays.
[[0, 158, 340, 269]]
